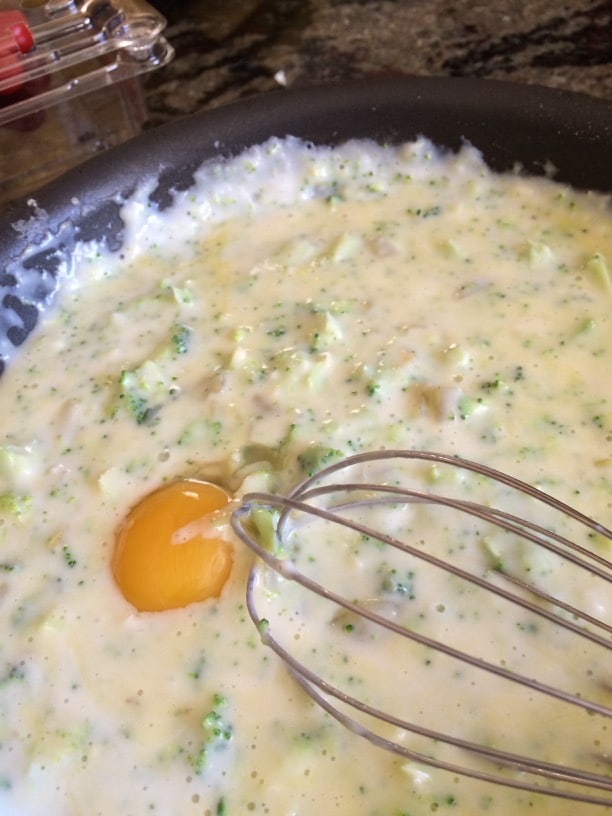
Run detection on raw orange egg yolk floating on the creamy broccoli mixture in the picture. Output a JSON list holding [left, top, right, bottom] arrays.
[[111, 479, 233, 612]]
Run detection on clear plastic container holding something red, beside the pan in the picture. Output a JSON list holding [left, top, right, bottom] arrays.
[[0, 0, 174, 204]]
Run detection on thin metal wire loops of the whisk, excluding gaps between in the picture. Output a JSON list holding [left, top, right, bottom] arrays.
[[232, 451, 612, 806]]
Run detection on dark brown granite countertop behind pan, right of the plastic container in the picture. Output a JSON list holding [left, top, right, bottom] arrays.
[[144, 0, 612, 127]]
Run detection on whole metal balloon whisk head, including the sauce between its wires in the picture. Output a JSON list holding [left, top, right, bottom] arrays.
[[232, 450, 612, 806]]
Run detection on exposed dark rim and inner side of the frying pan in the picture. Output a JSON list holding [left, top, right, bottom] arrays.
[[0, 77, 612, 375]]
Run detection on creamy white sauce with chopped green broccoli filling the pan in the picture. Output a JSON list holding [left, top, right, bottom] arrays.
[[0, 140, 612, 816]]
